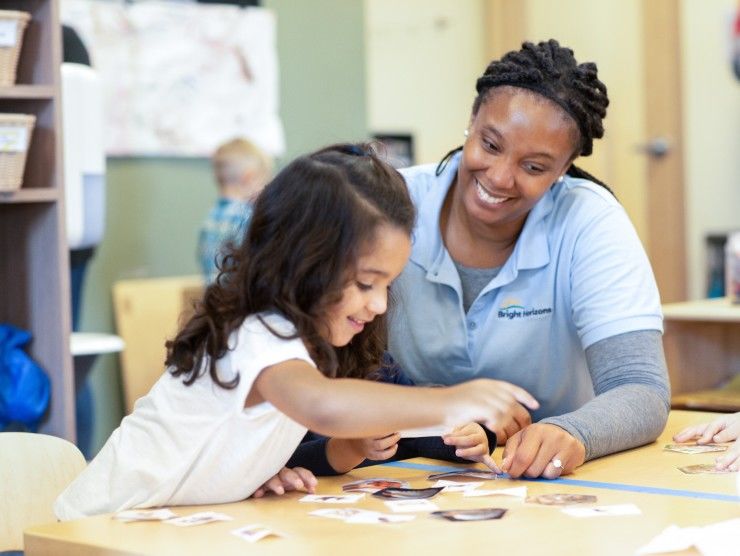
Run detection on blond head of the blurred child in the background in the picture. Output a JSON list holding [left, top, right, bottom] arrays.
[[213, 138, 272, 201]]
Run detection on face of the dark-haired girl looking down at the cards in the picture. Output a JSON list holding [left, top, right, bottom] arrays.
[[328, 224, 411, 347]]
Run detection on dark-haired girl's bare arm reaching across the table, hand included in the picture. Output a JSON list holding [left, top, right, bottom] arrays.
[[249, 360, 539, 438]]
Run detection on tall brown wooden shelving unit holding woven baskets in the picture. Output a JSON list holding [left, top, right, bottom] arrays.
[[0, 0, 75, 441]]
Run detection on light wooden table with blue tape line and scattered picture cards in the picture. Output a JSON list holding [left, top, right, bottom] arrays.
[[25, 411, 740, 556]]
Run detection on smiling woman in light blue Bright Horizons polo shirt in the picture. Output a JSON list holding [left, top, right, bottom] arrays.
[[389, 40, 670, 478]]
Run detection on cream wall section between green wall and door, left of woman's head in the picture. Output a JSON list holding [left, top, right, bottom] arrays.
[[365, 0, 487, 163]]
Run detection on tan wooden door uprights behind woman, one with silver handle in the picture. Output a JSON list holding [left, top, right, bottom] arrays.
[[484, 0, 688, 303]]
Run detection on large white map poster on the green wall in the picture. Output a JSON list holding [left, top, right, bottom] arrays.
[[61, 0, 285, 156]]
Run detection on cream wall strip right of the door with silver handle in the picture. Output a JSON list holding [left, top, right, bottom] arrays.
[[681, 0, 740, 298]]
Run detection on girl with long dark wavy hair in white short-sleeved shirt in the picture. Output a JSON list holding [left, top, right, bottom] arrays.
[[55, 145, 538, 520]]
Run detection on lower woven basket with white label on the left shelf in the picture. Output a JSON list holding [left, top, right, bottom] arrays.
[[0, 114, 36, 191]]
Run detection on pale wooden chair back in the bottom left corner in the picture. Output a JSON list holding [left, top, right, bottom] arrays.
[[0, 432, 86, 551]]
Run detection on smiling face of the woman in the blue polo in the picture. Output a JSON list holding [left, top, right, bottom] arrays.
[[454, 87, 578, 233]]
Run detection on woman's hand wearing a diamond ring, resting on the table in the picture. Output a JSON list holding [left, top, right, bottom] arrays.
[[501, 423, 586, 479]]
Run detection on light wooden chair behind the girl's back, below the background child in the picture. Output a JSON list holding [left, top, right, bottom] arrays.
[[113, 276, 205, 414]]
